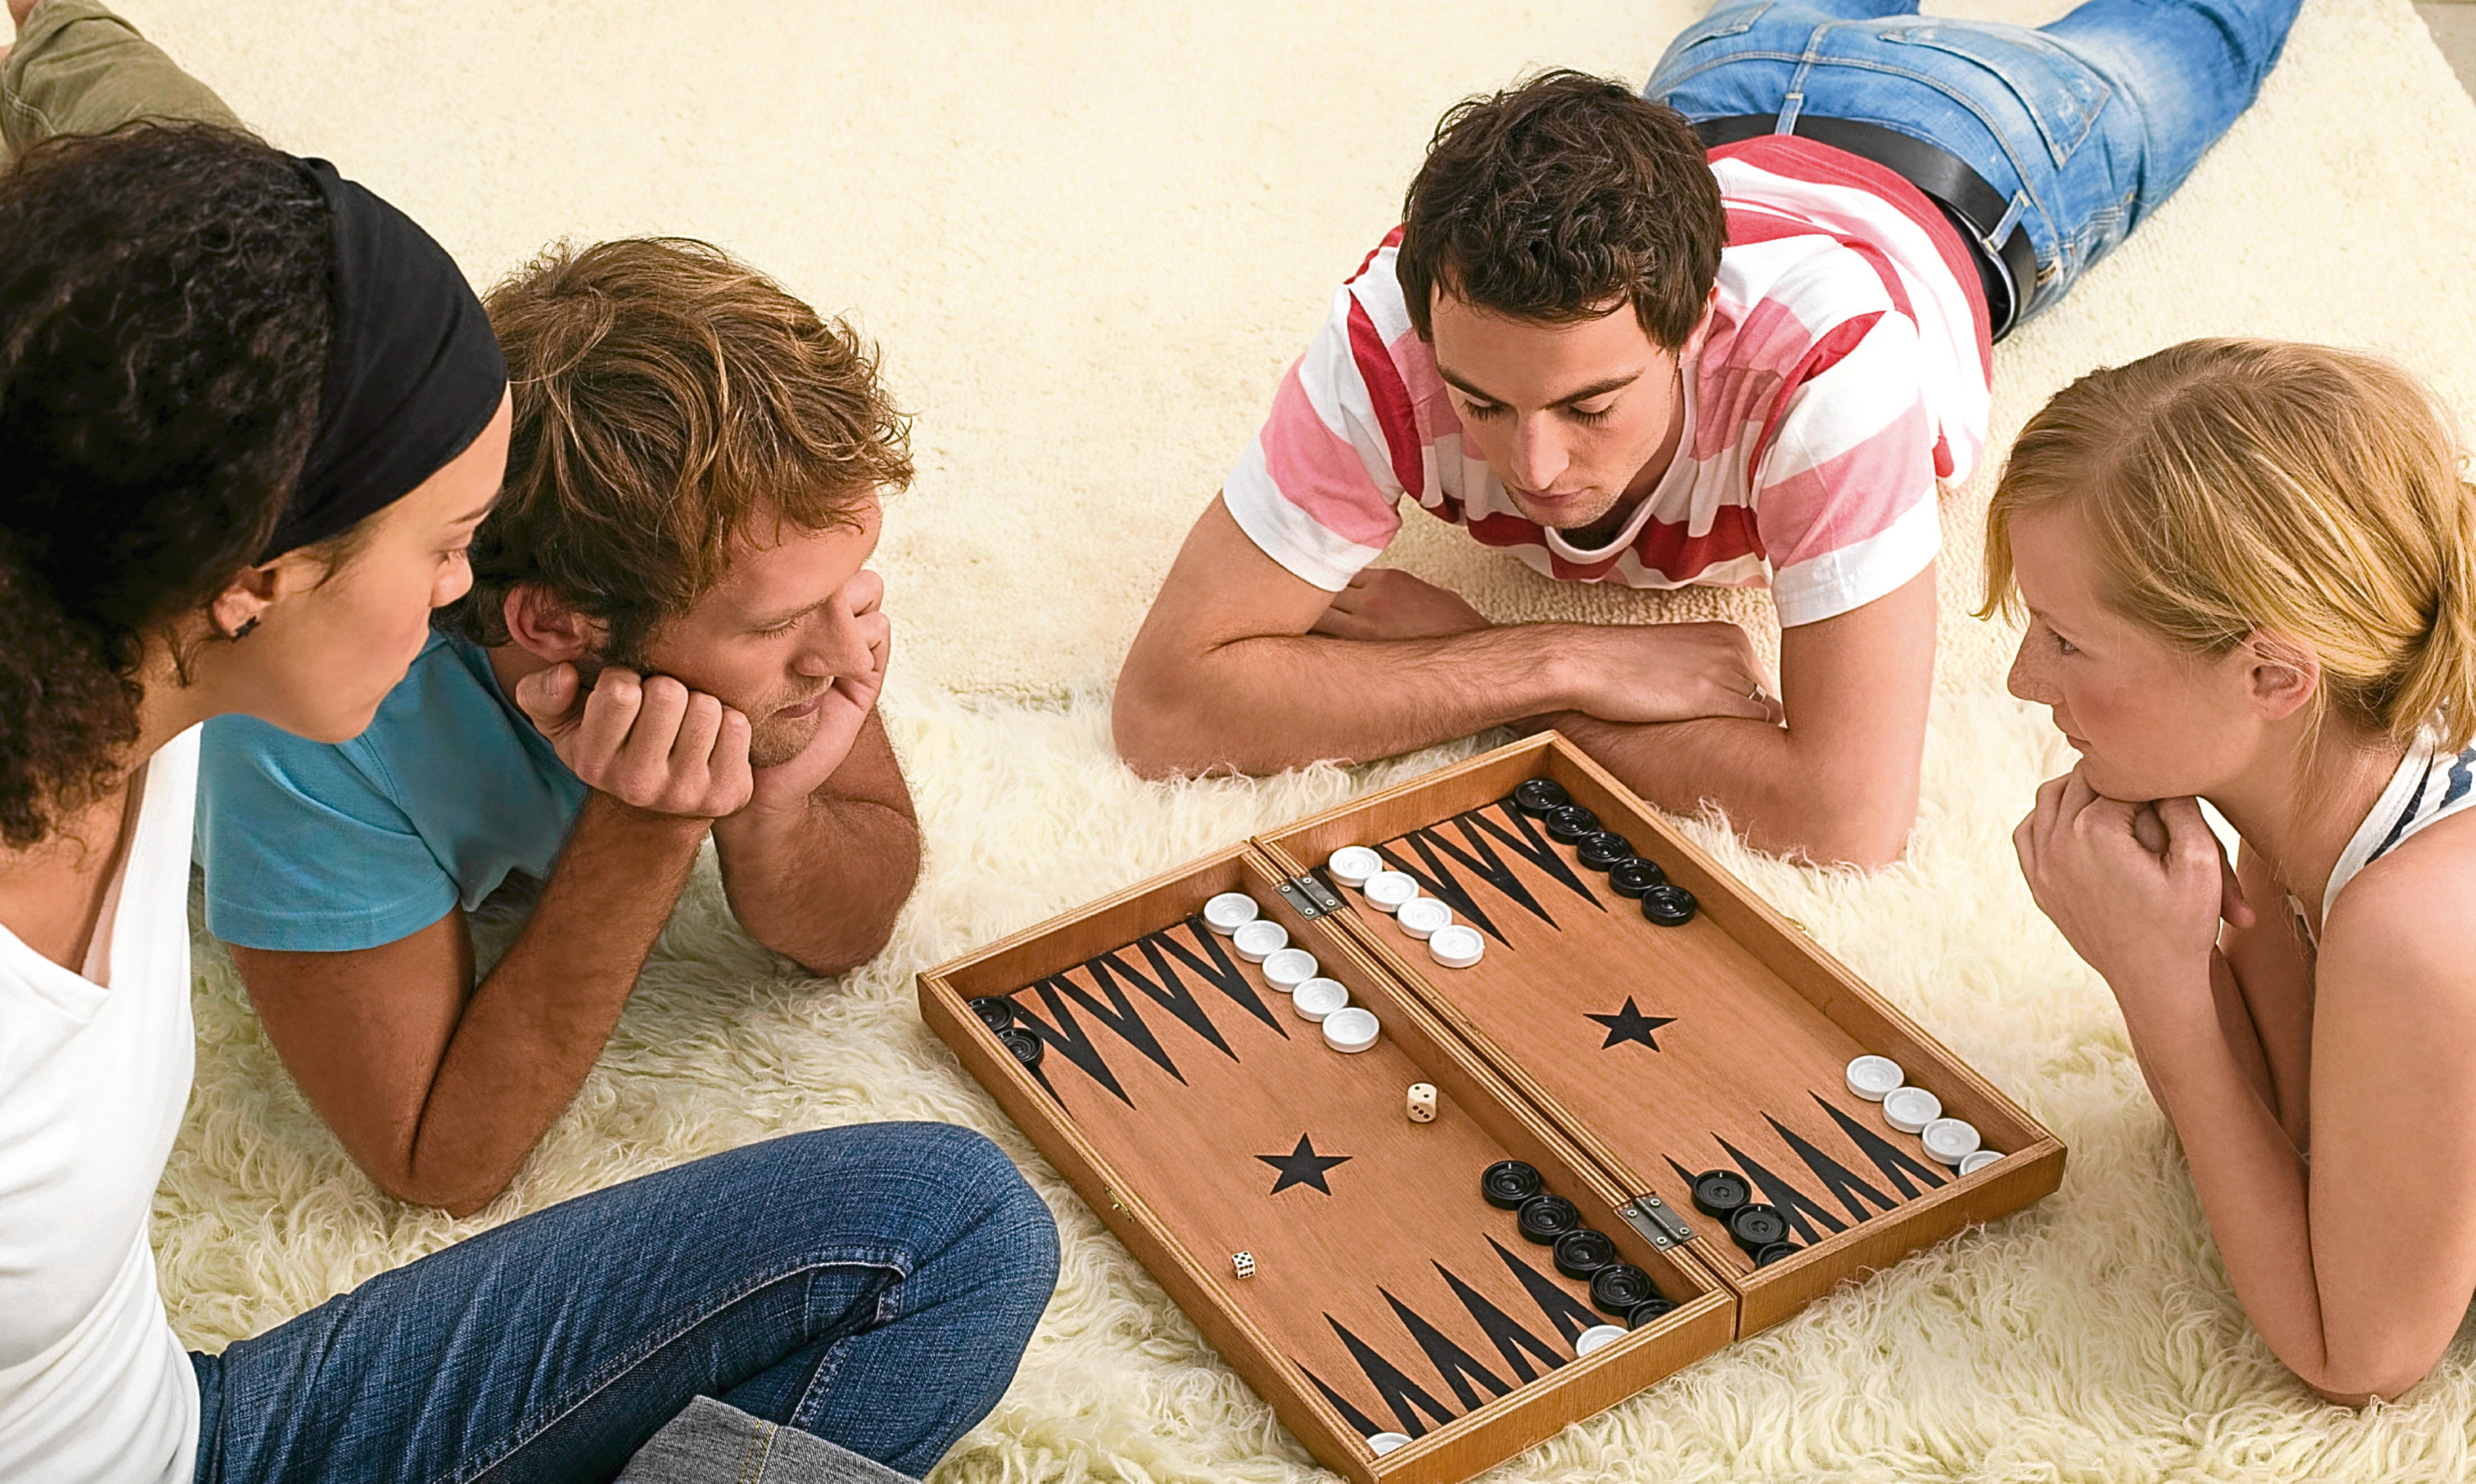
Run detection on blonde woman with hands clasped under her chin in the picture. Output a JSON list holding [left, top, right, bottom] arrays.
[[1986, 339, 2476, 1405]]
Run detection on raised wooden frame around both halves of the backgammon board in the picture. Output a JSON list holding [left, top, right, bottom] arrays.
[[919, 730, 2065, 1484]]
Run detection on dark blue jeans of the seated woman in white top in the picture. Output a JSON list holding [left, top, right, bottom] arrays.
[[191, 1122, 1057, 1484]]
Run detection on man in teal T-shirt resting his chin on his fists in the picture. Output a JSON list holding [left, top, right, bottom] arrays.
[[198, 238, 919, 1212]]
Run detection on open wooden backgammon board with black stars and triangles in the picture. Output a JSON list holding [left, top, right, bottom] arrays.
[[921, 733, 2065, 1484]]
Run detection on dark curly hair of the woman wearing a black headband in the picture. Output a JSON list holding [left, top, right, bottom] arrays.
[[0, 124, 334, 850]]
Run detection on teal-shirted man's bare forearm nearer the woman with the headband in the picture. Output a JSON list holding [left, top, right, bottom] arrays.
[[399, 793, 706, 1214]]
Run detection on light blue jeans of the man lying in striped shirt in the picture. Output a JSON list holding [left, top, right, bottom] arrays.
[[1642, 0, 2300, 319]]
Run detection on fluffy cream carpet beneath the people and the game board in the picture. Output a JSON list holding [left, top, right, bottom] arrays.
[[129, 0, 2476, 1484]]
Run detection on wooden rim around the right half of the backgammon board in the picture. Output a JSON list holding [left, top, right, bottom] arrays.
[[1260, 730, 2065, 1335]]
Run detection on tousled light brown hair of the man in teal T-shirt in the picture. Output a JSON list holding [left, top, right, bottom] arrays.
[[438, 238, 911, 669]]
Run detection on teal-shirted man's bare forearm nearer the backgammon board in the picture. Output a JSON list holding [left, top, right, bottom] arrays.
[[713, 796, 921, 974]]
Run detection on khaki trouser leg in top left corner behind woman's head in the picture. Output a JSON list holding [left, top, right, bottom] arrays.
[[0, 0, 243, 156]]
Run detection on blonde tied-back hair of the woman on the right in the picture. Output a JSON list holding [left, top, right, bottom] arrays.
[[1978, 339, 2476, 751]]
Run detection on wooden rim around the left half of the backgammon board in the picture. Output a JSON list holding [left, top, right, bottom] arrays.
[[919, 845, 1741, 1484]]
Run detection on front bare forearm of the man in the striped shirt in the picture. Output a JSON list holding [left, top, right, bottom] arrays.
[[1114, 624, 1572, 778]]
